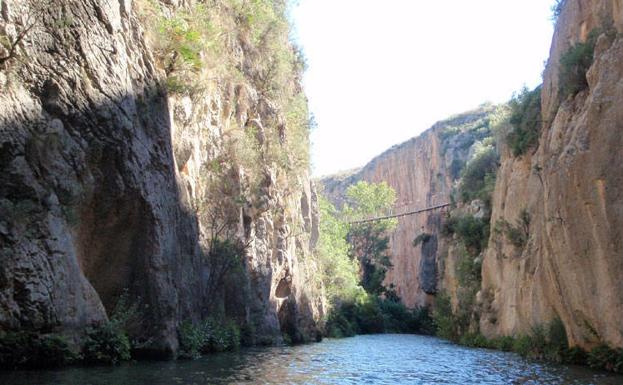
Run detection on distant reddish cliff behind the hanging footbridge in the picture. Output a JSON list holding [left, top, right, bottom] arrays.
[[321, 107, 493, 307]]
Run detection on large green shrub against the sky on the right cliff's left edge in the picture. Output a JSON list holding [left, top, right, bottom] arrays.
[[506, 86, 542, 156]]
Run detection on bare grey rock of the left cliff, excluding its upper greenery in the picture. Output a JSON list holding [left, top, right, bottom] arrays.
[[0, 0, 323, 352]]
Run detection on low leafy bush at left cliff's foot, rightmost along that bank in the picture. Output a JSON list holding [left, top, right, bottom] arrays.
[[178, 318, 242, 359]]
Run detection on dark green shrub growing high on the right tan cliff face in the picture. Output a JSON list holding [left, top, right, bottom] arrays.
[[559, 30, 599, 99]]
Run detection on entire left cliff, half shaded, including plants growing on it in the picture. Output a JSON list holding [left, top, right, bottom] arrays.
[[0, 0, 323, 355]]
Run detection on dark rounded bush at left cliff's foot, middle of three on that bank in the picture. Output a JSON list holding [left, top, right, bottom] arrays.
[[82, 321, 131, 364]]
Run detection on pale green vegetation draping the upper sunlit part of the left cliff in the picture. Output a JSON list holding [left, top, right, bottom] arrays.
[[142, 0, 312, 198]]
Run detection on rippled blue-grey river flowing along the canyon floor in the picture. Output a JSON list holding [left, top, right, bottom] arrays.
[[0, 334, 623, 385]]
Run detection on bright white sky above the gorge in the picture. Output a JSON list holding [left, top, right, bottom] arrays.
[[291, 0, 554, 176]]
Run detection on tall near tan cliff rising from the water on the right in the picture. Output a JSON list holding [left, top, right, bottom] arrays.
[[480, 0, 623, 348]]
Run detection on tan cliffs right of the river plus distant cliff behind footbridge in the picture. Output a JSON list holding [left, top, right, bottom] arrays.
[[320, 0, 623, 349]]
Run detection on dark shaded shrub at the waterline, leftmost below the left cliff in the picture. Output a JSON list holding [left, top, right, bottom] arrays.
[[0, 331, 77, 369]]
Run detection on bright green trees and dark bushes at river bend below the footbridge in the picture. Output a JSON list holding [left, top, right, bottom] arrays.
[[316, 182, 433, 338]]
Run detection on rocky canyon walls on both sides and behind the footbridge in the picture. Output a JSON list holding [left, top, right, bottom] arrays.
[[0, 0, 623, 366]]
